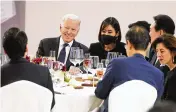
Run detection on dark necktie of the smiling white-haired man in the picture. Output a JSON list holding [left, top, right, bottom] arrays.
[[58, 43, 68, 63]]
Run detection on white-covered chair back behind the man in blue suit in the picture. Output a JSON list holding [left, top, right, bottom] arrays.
[[108, 80, 157, 112]]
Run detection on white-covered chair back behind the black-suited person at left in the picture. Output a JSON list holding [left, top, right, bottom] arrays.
[[0, 80, 52, 112]]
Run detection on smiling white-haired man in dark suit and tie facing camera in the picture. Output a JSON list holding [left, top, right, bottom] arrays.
[[37, 14, 88, 70]]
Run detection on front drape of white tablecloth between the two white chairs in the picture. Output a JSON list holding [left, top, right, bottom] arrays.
[[53, 86, 102, 112]]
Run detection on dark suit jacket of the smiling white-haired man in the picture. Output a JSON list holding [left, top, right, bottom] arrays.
[[36, 37, 89, 70]]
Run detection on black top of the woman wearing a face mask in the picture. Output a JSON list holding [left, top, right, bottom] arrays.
[[89, 42, 126, 61]]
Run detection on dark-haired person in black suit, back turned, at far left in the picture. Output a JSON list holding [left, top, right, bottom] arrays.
[[1, 27, 55, 108]]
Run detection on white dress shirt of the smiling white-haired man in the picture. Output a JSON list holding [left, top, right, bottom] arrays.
[[57, 37, 73, 64]]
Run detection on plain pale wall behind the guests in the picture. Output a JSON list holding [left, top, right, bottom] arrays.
[[25, 1, 176, 54]]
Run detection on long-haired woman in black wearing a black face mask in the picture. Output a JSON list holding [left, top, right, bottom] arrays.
[[89, 17, 126, 61]]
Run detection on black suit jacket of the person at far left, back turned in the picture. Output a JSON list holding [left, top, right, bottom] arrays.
[[1, 58, 55, 108]]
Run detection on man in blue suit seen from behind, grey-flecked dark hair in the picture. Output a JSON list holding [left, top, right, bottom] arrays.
[[95, 26, 164, 112]]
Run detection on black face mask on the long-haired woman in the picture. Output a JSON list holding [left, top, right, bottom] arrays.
[[100, 35, 117, 45]]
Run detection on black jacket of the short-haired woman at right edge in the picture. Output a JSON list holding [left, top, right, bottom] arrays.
[[163, 67, 176, 103]]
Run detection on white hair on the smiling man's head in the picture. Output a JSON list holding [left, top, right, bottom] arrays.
[[61, 14, 81, 26]]
